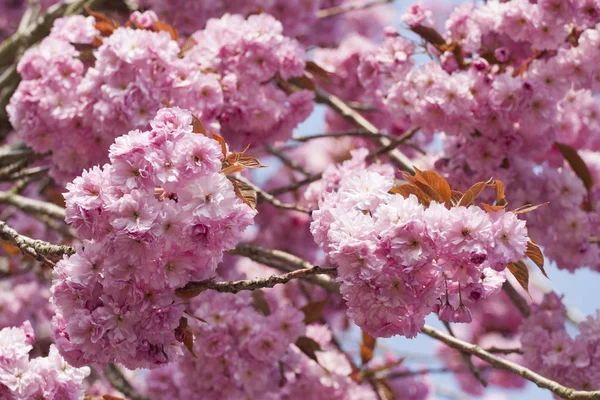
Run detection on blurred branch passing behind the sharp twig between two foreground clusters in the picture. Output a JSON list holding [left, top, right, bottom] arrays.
[[229, 244, 340, 293]]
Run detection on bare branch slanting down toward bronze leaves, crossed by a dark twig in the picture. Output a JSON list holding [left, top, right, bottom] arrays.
[[315, 87, 415, 174]]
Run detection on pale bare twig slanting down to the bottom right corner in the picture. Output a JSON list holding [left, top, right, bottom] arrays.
[[421, 325, 600, 400]]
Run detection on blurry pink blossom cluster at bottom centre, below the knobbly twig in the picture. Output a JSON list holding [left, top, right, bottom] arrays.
[[147, 291, 305, 400]]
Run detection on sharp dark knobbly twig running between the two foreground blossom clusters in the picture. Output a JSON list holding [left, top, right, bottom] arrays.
[[177, 266, 337, 294]]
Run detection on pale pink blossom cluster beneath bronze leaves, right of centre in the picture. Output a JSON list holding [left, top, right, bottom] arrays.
[[311, 152, 529, 337]]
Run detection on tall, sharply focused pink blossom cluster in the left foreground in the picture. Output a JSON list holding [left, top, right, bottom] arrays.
[[52, 107, 255, 368]]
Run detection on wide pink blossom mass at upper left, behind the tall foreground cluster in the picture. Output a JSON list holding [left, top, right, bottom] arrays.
[[7, 12, 313, 182]]
